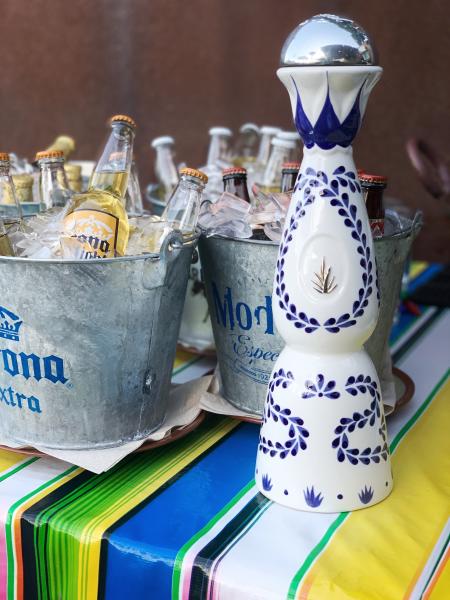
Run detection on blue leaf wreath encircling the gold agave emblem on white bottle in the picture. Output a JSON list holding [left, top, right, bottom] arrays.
[[275, 166, 378, 333]]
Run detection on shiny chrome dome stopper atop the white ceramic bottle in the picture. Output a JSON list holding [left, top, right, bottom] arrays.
[[280, 15, 378, 67]]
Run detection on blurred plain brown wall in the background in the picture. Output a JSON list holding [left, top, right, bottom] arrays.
[[0, 0, 450, 261]]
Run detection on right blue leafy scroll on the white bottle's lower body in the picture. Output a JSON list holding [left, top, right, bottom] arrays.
[[331, 375, 389, 465]]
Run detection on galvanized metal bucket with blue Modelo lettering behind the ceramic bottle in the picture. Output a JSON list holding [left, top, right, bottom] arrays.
[[199, 215, 421, 415]]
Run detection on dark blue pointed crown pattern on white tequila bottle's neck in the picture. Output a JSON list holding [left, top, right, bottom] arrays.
[[291, 77, 365, 150]]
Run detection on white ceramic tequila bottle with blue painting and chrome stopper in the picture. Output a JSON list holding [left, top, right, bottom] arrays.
[[256, 15, 392, 512]]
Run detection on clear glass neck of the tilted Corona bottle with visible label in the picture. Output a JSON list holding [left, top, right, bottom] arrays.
[[88, 121, 134, 200]]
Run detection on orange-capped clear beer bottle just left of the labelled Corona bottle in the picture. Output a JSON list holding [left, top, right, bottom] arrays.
[[35, 150, 72, 210]]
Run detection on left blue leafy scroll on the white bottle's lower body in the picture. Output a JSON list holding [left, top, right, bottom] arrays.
[[259, 369, 309, 459]]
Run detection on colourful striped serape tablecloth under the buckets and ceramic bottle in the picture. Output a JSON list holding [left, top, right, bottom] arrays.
[[0, 264, 450, 600]]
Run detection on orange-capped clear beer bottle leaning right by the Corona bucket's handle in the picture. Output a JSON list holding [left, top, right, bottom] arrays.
[[161, 167, 208, 235]]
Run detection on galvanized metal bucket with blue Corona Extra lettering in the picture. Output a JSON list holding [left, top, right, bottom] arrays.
[[0, 232, 197, 449]]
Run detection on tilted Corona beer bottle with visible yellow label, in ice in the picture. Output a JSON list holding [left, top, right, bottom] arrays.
[[64, 115, 136, 259]]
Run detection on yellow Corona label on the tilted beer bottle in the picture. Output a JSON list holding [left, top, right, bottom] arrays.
[[64, 208, 119, 259]]
